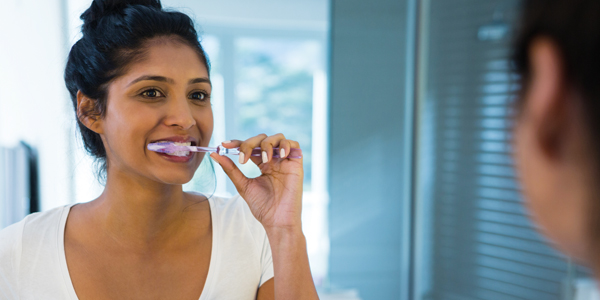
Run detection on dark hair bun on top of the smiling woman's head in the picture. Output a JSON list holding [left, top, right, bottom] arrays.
[[81, 0, 162, 33]]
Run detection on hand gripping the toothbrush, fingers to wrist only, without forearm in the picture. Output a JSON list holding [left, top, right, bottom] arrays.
[[210, 133, 304, 230]]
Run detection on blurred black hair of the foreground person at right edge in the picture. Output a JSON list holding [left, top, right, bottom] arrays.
[[513, 0, 600, 131]]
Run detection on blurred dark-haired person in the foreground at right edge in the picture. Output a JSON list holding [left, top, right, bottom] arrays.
[[515, 0, 600, 276]]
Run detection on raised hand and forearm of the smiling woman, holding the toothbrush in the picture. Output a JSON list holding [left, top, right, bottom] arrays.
[[210, 134, 319, 300]]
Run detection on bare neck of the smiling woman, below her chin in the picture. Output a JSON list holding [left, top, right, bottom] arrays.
[[92, 170, 191, 249]]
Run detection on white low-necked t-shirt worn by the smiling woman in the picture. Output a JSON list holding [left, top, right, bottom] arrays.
[[0, 196, 273, 300]]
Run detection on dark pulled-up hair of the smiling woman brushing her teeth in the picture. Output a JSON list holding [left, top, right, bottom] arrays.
[[65, 0, 210, 178]]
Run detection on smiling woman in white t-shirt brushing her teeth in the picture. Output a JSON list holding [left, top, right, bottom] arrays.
[[0, 0, 318, 300]]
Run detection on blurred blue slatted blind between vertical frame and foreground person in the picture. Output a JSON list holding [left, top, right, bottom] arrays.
[[418, 0, 588, 300]]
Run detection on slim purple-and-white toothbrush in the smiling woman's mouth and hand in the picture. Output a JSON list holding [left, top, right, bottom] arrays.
[[148, 142, 302, 158]]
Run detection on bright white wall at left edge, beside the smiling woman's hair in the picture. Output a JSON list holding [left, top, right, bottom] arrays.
[[0, 0, 73, 210]]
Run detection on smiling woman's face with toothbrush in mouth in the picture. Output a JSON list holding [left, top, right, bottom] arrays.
[[100, 38, 213, 184]]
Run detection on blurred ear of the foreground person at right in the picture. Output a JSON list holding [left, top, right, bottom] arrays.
[[525, 38, 573, 158]]
